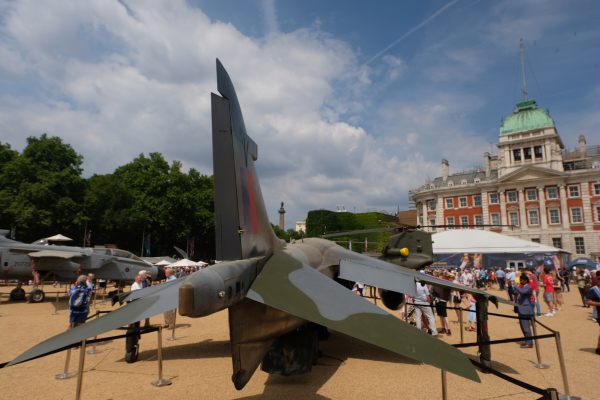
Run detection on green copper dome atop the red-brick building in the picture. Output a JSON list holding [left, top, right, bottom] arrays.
[[500, 99, 555, 136]]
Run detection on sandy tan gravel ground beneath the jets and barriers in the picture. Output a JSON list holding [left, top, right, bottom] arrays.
[[0, 286, 600, 400]]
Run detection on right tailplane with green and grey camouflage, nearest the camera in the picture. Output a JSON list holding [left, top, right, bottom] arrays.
[[247, 252, 480, 382]]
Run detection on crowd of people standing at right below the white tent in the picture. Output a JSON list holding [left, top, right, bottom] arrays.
[[386, 254, 600, 354]]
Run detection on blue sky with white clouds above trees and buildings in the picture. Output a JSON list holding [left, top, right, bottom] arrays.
[[0, 0, 600, 228]]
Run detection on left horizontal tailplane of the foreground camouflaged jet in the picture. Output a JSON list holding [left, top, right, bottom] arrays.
[[7, 280, 184, 367]]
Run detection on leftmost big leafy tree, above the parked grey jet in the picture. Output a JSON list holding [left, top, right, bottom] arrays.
[[0, 134, 85, 241]]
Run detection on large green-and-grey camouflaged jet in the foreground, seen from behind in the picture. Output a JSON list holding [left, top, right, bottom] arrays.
[[8, 60, 496, 389]]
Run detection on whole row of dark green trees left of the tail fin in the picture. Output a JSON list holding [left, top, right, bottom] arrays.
[[0, 134, 214, 259]]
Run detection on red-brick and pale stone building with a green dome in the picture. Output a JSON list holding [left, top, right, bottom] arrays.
[[410, 99, 600, 261]]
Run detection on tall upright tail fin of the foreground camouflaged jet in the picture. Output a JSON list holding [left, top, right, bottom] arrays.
[[211, 59, 280, 260]]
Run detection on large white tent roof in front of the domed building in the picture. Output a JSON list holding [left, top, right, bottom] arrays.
[[431, 229, 567, 254]]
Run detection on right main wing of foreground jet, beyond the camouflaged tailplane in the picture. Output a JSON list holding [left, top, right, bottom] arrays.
[[340, 259, 513, 304]]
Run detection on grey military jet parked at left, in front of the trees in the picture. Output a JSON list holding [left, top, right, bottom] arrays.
[[0, 230, 164, 303]]
